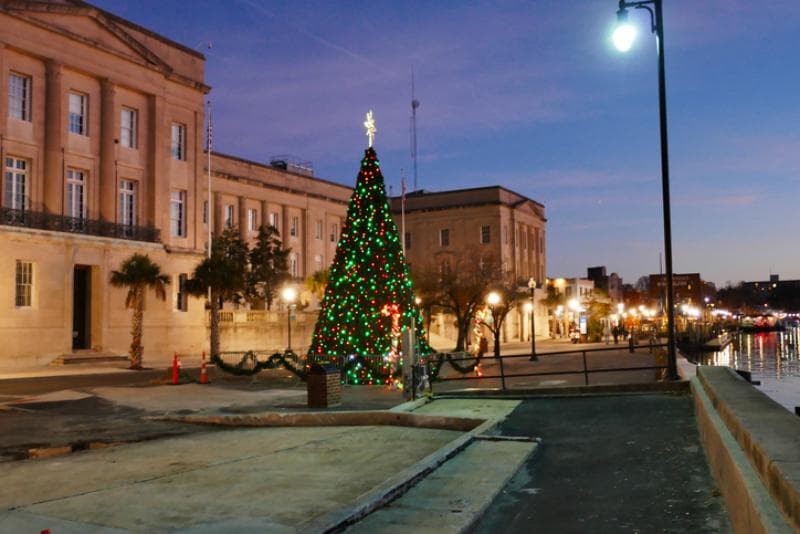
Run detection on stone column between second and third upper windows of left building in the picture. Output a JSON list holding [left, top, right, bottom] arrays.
[[96, 78, 119, 222]]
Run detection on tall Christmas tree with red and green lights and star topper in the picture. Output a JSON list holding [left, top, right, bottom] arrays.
[[309, 112, 432, 384]]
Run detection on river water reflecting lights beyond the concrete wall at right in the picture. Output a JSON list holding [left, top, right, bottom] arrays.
[[705, 327, 800, 413]]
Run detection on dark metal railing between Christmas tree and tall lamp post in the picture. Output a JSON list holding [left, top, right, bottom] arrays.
[[424, 343, 668, 390]]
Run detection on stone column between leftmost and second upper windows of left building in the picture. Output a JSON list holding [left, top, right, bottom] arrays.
[[43, 60, 66, 214]]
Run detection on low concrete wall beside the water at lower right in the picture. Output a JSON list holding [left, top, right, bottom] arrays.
[[692, 366, 800, 533]]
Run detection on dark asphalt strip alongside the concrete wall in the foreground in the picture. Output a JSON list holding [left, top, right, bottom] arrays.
[[475, 394, 730, 533]]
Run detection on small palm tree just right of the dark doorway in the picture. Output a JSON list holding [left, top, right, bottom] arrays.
[[111, 254, 169, 369]]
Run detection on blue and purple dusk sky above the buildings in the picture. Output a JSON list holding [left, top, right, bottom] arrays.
[[94, 0, 800, 285]]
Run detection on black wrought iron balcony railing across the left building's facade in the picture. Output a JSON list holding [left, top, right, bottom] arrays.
[[0, 208, 161, 243]]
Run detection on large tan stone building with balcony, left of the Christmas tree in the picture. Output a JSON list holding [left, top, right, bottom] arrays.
[[0, 0, 351, 366]]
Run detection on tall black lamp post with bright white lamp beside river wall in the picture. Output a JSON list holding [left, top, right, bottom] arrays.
[[613, 0, 678, 386]]
